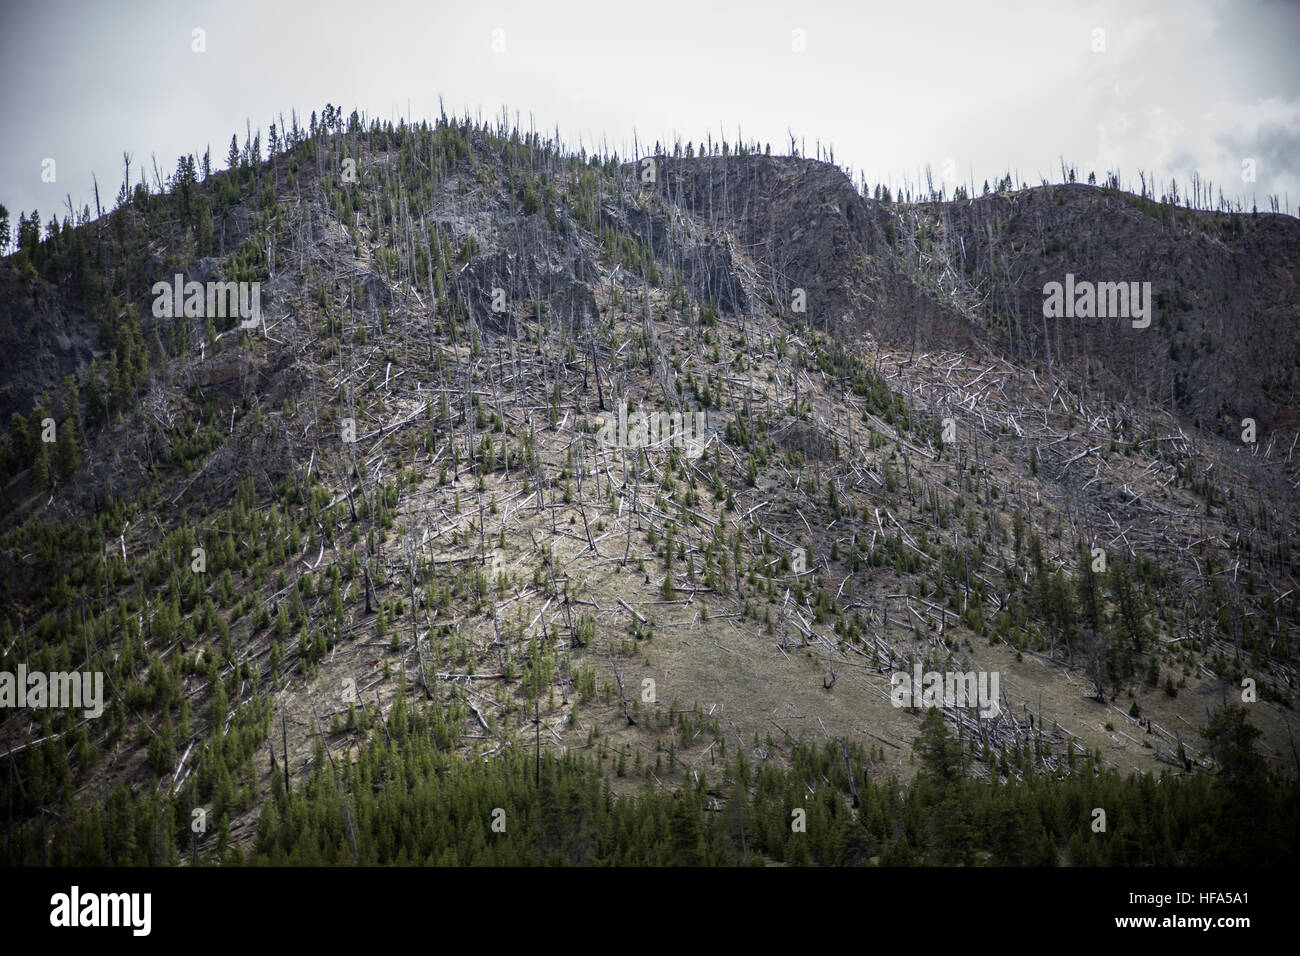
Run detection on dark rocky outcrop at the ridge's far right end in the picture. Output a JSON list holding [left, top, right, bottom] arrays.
[[936, 183, 1300, 436]]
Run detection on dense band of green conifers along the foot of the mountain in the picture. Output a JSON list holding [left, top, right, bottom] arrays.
[[5, 697, 1300, 866]]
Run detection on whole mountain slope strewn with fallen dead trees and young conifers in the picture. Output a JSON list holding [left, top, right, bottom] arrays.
[[0, 107, 1300, 864]]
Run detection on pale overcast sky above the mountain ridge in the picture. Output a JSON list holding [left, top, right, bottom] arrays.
[[0, 0, 1300, 238]]
